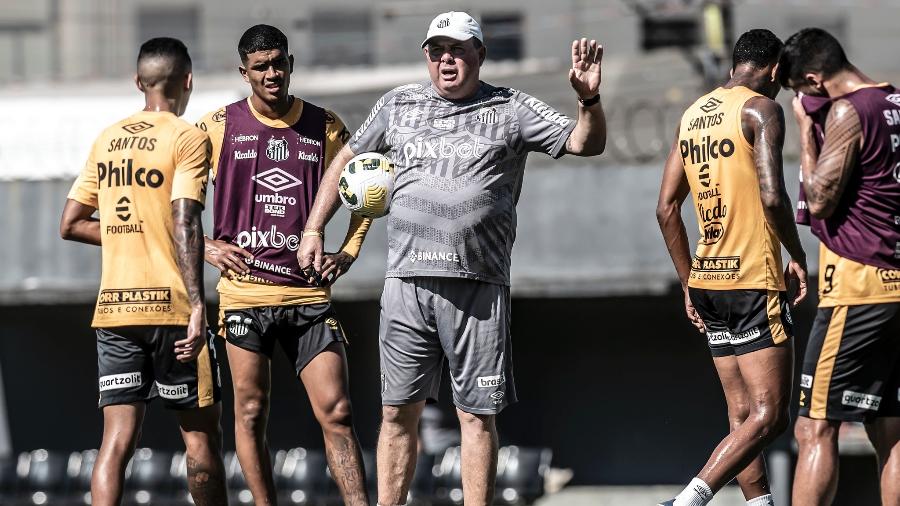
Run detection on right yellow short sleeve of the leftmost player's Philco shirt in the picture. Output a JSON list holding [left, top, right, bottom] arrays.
[[171, 127, 212, 204]]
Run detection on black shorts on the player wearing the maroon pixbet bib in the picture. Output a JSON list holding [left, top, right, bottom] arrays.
[[224, 303, 346, 375]]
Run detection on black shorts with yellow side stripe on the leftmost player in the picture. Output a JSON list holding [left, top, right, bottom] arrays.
[[97, 325, 222, 409]]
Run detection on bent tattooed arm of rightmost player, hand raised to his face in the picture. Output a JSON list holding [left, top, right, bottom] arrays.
[[794, 98, 862, 219]]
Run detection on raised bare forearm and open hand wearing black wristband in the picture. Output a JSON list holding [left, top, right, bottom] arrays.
[[566, 39, 606, 156]]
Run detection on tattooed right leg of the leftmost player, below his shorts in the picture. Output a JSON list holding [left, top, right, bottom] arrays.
[[178, 404, 228, 506]]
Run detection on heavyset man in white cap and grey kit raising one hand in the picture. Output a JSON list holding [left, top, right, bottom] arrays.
[[299, 12, 606, 506]]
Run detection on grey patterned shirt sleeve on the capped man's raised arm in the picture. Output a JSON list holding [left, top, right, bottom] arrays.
[[513, 91, 575, 158]]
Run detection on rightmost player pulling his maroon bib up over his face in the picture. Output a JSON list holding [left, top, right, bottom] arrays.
[[780, 28, 900, 506]]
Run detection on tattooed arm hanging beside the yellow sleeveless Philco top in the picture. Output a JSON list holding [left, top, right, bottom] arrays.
[[741, 97, 806, 305]]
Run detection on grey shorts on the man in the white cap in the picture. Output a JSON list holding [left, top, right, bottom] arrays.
[[379, 277, 516, 415]]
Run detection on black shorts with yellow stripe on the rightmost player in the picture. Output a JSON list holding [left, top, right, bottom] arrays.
[[800, 303, 900, 422]]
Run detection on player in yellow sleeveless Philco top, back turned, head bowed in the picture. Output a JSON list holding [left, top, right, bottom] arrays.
[[656, 30, 806, 506]]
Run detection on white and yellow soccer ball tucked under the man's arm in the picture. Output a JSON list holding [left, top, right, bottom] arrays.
[[338, 153, 394, 218]]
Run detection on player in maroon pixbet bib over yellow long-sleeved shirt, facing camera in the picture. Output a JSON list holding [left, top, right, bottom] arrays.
[[198, 25, 370, 505]]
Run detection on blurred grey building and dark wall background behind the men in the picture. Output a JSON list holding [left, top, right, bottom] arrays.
[[0, 0, 900, 505]]
